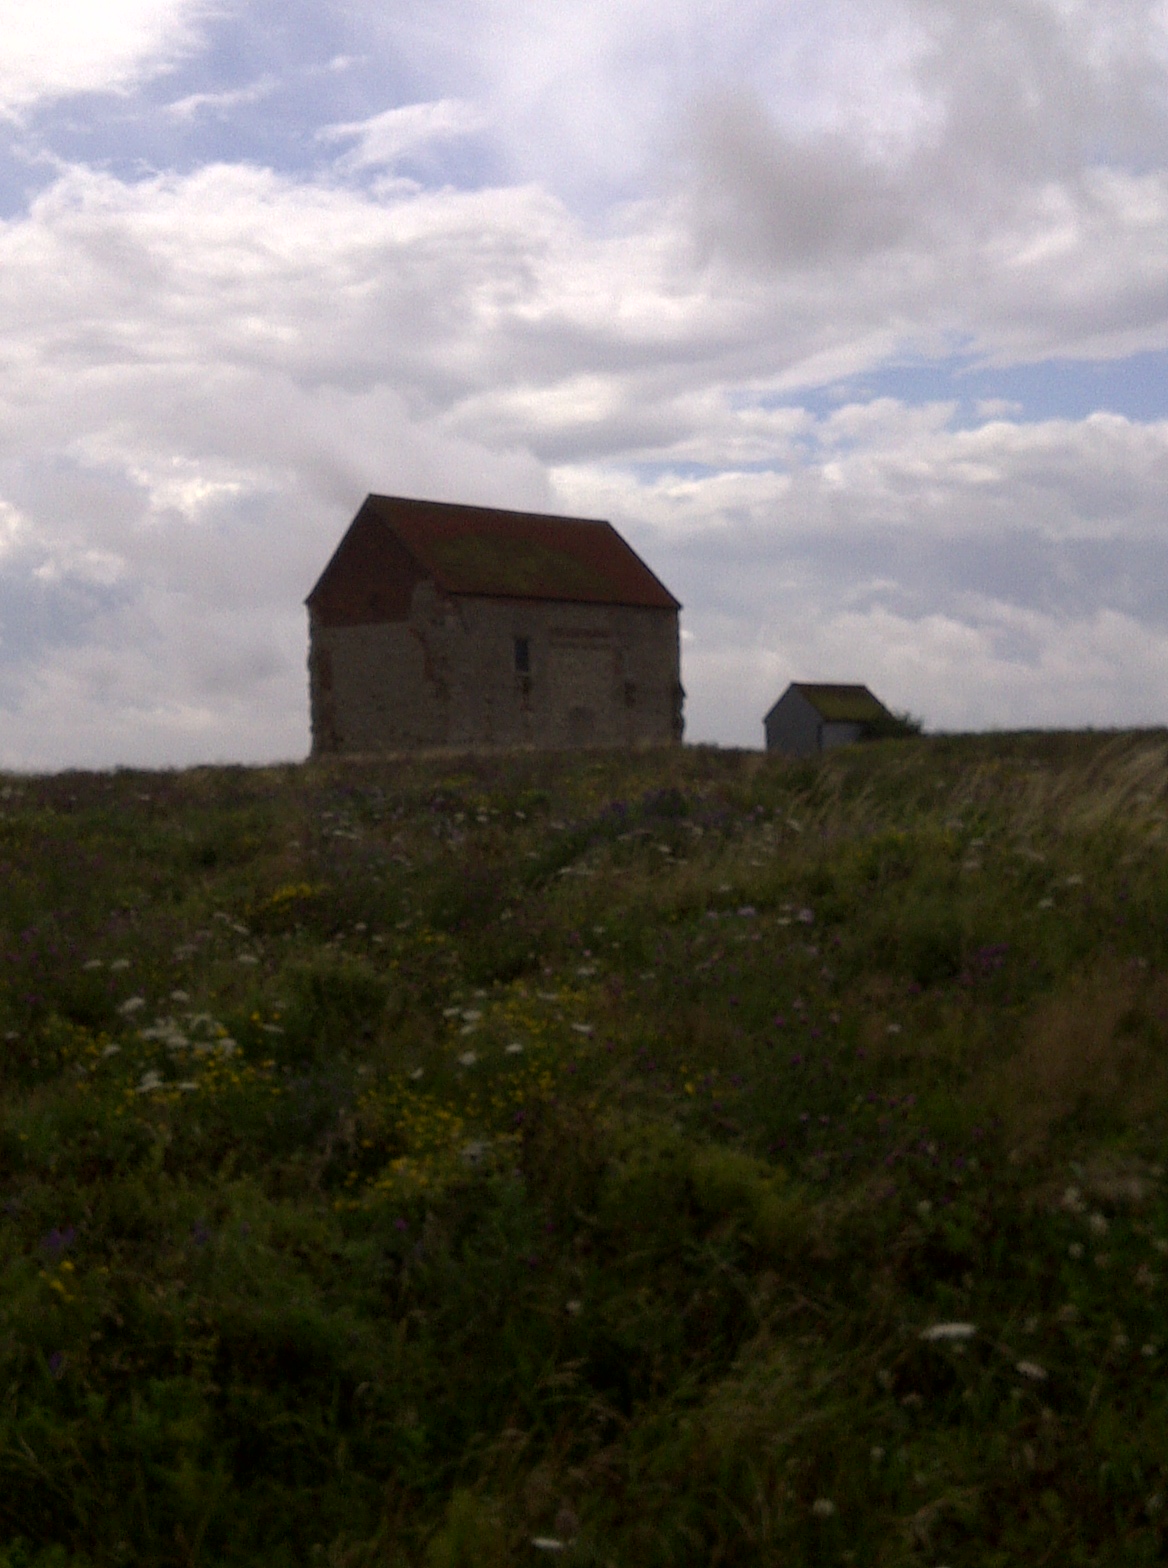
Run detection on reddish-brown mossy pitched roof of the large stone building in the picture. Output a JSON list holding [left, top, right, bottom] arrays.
[[307, 495, 680, 610]]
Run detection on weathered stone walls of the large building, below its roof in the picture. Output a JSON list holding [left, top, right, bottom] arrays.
[[309, 582, 682, 754]]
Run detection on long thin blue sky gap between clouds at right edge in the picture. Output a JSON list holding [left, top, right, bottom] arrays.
[[751, 350, 1168, 428]]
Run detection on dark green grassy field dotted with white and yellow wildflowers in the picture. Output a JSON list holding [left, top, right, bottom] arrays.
[[0, 732, 1168, 1568]]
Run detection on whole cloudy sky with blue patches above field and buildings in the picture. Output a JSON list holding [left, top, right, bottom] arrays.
[[0, 0, 1168, 770]]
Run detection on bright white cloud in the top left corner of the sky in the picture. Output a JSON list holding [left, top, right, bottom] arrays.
[[0, 0, 209, 118]]
